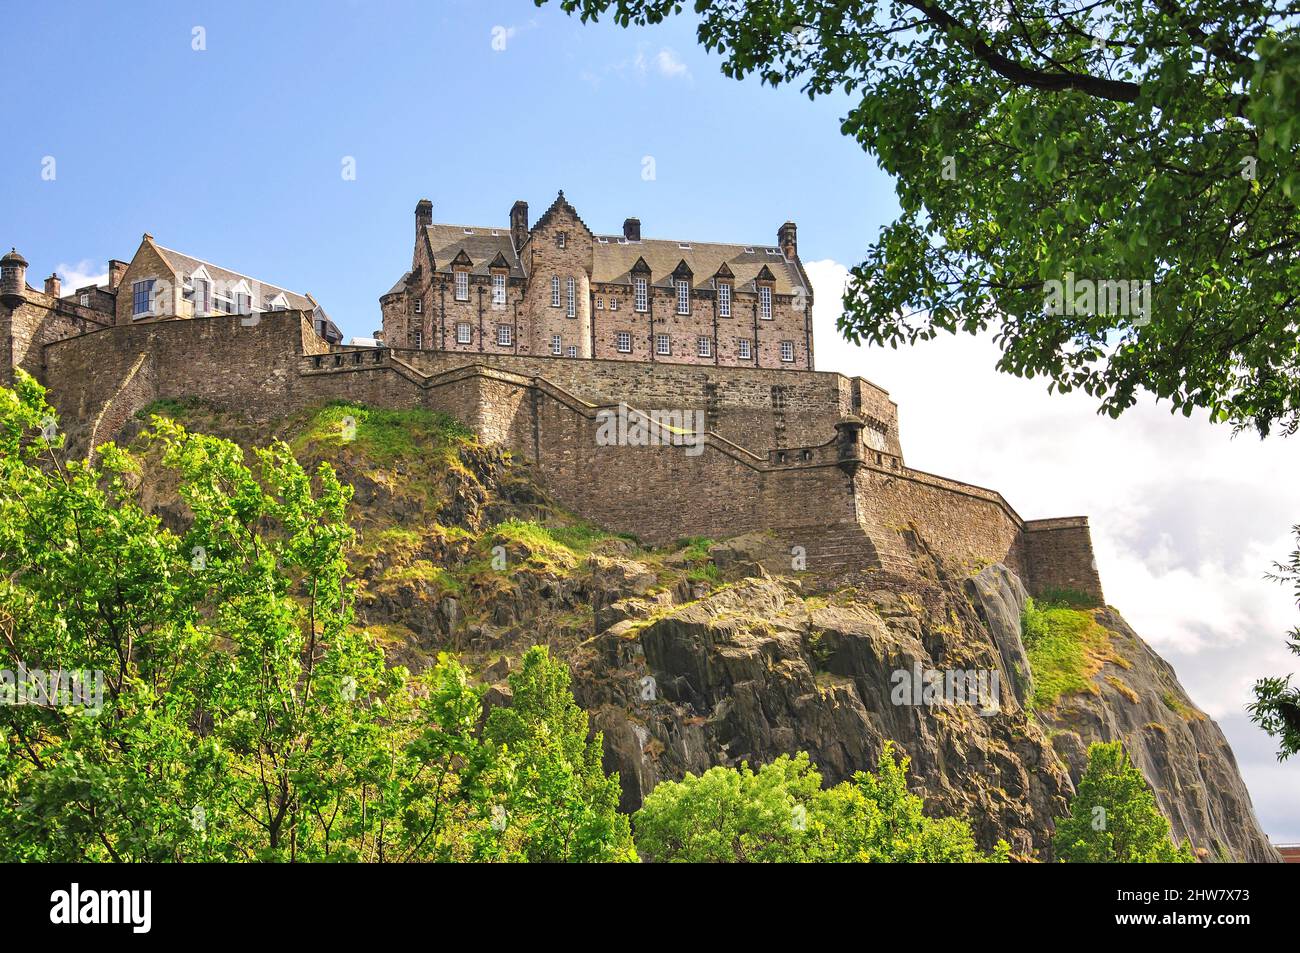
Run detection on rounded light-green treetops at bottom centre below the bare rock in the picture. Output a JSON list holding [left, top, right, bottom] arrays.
[[636, 744, 1008, 863]]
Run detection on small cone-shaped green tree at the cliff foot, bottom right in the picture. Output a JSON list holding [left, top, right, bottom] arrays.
[[1053, 741, 1195, 863]]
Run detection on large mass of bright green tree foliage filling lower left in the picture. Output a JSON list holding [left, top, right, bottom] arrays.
[[0, 372, 634, 862]]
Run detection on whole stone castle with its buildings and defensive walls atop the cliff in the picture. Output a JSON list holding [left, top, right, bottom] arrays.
[[0, 192, 1102, 602]]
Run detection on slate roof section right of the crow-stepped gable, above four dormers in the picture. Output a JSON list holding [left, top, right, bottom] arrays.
[[592, 235, 805, 294]]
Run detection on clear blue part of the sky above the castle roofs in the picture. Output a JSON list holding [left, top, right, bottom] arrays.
[[0, 0, 893, 334]]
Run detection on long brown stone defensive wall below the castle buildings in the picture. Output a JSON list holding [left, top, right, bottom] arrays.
[[22, 312, 1101, 601]]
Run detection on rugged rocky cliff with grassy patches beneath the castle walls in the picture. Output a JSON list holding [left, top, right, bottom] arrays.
[[116, 403, 1275, 861]]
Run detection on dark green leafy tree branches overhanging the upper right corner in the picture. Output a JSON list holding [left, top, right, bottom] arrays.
[[537, 0, 1300, 433]]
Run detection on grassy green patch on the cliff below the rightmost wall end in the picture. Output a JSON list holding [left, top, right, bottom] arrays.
[[1021, 599, 1115, 707]]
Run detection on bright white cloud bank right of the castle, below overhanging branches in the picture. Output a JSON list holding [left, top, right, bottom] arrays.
[[805, 260, 1300, 831]]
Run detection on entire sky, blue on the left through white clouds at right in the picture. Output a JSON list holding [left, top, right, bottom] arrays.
[[0, 0, 1300, 841]]
